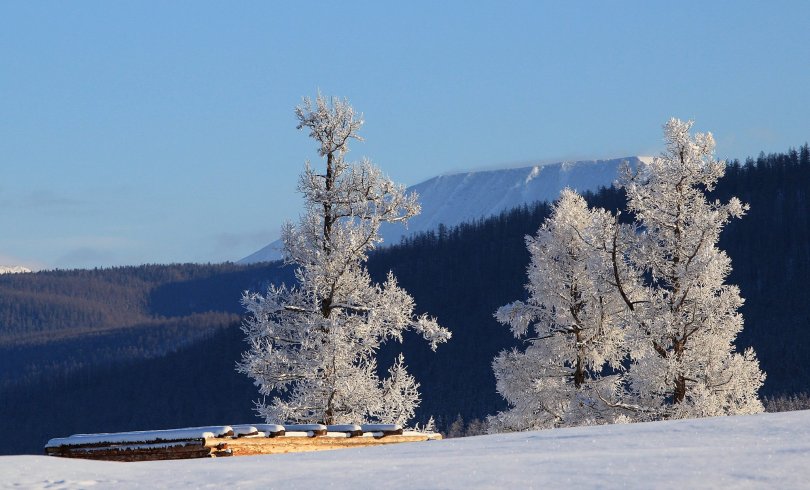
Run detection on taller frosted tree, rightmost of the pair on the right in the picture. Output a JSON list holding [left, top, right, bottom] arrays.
[[614, 119, 765, 419]]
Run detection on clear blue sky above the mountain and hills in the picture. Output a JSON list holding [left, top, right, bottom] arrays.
[[0, 0, 810, 268]]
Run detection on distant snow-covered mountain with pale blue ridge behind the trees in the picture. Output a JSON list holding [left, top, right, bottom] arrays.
[[239, 157, 648, 264]]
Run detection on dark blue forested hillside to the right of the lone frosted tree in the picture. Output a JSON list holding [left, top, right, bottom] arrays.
[[370, 144, 810, 418]]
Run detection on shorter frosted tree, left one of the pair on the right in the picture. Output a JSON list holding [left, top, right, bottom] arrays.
[[489, 189, 627, 432]]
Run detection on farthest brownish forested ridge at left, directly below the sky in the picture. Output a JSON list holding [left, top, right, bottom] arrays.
[[0, 264, 275, 347]]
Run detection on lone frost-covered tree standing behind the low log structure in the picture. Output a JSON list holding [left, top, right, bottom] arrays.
[[238, 95, 450, 424]]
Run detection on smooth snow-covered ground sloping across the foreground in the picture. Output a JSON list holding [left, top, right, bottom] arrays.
[[0, 411, 810, 489]]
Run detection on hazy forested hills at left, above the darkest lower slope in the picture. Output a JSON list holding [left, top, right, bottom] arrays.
[[0, 264, 292, 387]]
